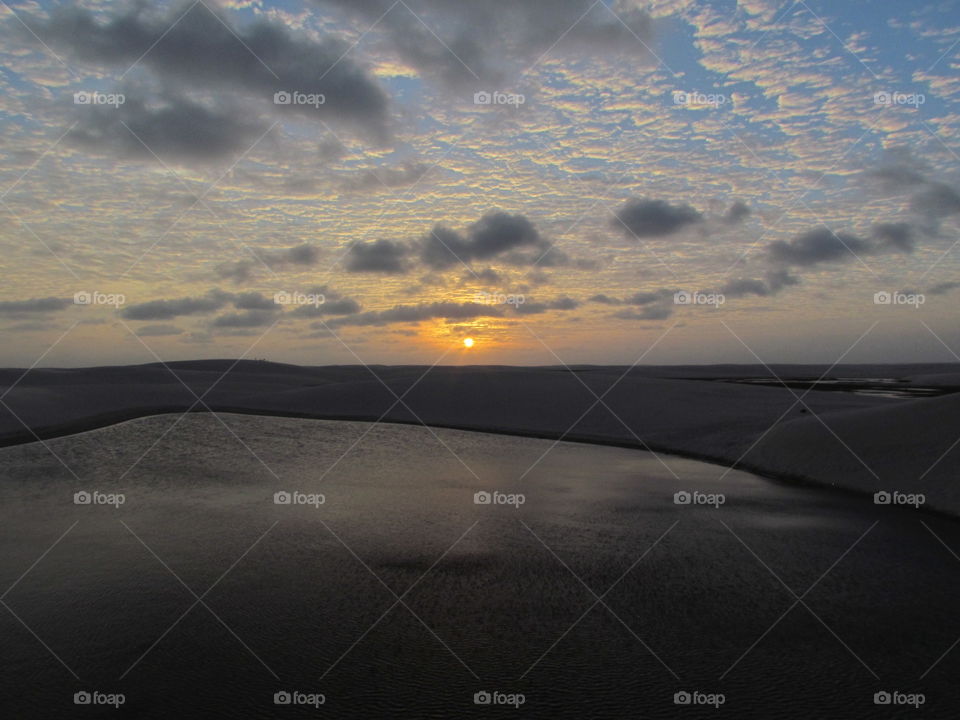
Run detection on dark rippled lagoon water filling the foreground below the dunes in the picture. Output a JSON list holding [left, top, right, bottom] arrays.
[[0, 415, 960, 718]]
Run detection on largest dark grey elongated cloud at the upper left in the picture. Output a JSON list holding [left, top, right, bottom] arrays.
[[27, 3, 388, 137]]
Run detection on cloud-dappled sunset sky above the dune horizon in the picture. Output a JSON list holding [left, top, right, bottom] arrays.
[[0, 0, 960, 367]]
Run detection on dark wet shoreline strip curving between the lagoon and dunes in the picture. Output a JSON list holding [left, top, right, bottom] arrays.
[[0, 406, 960, 520]]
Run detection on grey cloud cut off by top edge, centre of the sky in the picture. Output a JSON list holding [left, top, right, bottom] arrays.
[[314, 0, 651, 89]]
